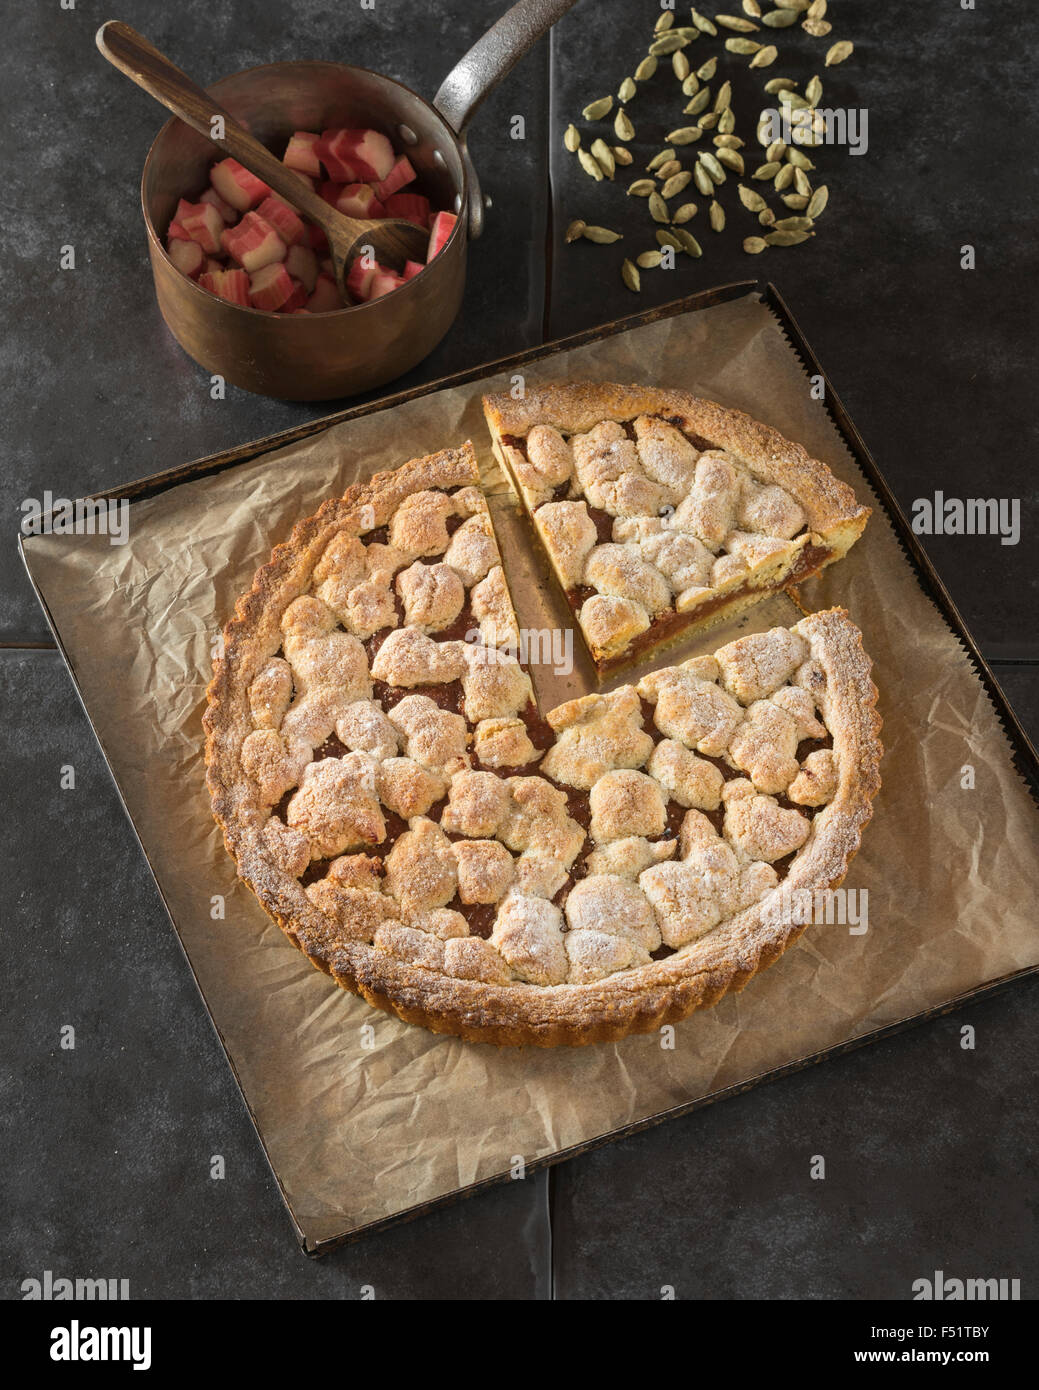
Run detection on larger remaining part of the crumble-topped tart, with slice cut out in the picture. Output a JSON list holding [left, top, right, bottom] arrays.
[[204, 445, 880, 1047]]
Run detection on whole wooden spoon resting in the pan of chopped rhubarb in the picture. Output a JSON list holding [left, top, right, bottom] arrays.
[[97, 19, 430, 296]]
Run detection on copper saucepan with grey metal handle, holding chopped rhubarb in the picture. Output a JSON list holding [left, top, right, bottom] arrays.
[[127, 0, 574, 400]]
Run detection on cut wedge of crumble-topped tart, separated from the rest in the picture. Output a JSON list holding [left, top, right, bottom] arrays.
[[484, 382, 869, 674]]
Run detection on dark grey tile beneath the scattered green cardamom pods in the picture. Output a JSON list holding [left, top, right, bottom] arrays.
[[549, 0, 1039, 656]]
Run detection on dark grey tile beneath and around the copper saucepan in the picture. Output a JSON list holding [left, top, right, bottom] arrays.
[[0, 0, 548, 641]]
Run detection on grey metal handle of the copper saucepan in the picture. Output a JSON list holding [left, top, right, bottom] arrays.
[[433, 0, 576, 239]]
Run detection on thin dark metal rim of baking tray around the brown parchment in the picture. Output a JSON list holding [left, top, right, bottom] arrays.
[[19, 281, 1039, 1254]]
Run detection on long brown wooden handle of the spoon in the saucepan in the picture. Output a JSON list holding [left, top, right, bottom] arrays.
[[97, 19, 364, 236]]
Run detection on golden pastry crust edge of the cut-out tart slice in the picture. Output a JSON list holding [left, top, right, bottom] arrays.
[[484, 382, 871, 676]]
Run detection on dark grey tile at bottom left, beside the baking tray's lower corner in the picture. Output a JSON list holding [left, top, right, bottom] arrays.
[[0, 651, 549, 1300]]
